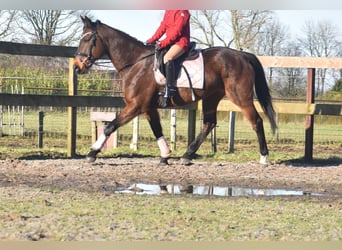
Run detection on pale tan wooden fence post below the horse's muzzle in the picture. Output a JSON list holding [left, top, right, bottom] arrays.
[[67, 58, 77, 157]]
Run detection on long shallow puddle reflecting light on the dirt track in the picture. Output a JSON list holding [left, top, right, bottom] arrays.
[[115, 183, 322, 197]]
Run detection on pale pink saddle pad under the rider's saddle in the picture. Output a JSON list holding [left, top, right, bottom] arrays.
[[154, 53, 204, 89]]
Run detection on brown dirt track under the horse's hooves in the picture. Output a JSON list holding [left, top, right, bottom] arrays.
[[0, 157, 342, 198]]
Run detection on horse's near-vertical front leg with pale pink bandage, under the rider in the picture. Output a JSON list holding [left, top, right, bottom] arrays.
[[145, 109, 171, 165]]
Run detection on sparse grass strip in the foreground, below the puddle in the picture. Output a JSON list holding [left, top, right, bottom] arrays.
[[0, 187, 342, 241]]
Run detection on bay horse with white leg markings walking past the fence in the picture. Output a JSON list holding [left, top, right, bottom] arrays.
[[74, 16, 277, 165]]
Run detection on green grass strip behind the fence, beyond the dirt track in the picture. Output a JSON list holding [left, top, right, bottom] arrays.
[[0, 136, 342, 165]]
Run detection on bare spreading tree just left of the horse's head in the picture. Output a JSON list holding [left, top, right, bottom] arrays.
[[17, 10, 89, 45]]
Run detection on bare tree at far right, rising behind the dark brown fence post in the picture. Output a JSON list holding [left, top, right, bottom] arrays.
[[298, 21, 341, 96]]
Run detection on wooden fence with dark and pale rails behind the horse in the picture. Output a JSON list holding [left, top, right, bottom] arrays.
[[0, 42, 342, 162]]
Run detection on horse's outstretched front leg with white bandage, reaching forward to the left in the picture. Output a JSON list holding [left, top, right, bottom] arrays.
[[86, 106, 140, 162]]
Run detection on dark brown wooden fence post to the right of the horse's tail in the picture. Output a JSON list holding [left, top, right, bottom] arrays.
[[304, 68, 316, 163]]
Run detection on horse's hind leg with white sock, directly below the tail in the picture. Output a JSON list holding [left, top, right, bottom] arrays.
[[241, 105, 268, 165]]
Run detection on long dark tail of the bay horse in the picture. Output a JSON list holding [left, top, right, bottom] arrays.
[[248, 53, 277, 134]]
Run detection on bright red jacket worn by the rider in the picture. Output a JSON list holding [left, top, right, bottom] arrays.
[[147, 10, 190, 50]]
